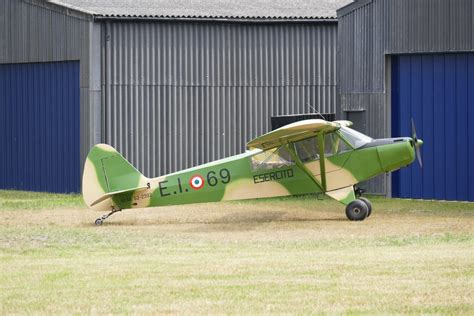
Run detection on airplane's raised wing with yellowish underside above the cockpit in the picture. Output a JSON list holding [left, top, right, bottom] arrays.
[[247, 119, 349, 150]]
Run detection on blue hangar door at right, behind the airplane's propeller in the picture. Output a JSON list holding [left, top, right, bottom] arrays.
[[392, 53, 474, 201]]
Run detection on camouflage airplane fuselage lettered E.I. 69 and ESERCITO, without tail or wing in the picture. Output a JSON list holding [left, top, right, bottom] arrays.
[[106, 138, 414, 209]]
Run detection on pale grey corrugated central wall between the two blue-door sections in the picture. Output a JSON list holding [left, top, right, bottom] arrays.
[[103, 22, 337, 176]]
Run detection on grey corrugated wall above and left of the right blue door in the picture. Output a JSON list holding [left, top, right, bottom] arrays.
[[337, 0, 474, 193]]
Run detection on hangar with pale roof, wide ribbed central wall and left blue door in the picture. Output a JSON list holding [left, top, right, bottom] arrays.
[[0, 0, 349, 192]]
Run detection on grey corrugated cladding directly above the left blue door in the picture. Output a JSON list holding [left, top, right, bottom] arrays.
[[0, 0, 89, 65]]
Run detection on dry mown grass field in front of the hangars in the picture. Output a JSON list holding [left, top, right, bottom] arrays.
[[0, 191, 474, 315]]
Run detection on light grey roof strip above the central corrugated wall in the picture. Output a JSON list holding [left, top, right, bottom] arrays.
[[48, 0, 352, 20]]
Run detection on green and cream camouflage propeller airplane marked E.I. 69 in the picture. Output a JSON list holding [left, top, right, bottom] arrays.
[[82, 119, 423, 225]]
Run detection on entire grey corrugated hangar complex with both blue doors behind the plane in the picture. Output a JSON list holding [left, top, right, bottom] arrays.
[[0, 0, 474, 201]]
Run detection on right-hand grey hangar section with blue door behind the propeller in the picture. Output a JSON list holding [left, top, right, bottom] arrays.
[[338, 0, 474, 201]]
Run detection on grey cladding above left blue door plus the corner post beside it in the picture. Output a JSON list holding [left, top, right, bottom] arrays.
[[0, 0, 101, 191]]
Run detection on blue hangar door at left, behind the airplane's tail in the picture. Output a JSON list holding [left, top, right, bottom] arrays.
[[0, 61, 81, 193]]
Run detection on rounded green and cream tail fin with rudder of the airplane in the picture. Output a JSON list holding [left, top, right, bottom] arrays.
[[82, 144, 148, 210]]
